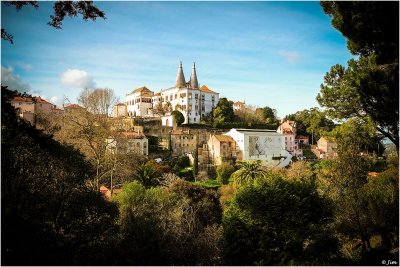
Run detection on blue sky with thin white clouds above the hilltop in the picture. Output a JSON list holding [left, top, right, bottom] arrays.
[[1, 1, 351, 117]]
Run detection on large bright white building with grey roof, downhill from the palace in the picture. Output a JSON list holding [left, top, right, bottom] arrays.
[[225, 129, 292, 167]]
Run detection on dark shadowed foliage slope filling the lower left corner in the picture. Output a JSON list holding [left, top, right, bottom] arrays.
[[1, 87, 118, 265]]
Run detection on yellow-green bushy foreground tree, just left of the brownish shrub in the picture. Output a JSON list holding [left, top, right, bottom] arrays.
[[113, 181, 177, 265]]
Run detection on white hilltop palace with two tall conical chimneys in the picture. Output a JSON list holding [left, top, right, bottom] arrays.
[[126, 62, 219, 124]]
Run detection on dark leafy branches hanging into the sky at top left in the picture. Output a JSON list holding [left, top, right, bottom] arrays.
[[1, 1, 106, 43]]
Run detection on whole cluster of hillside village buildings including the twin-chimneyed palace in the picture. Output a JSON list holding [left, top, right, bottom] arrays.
[[11, 63, 336, 179]]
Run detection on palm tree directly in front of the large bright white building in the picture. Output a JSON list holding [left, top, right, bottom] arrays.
[[232, 160, 266, 185]]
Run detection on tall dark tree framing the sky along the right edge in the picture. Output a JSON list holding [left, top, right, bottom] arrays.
[[317, 2, 399, 151]]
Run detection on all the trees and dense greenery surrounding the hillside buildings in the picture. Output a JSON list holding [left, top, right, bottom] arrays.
[[1, 1, 399, 265]]
